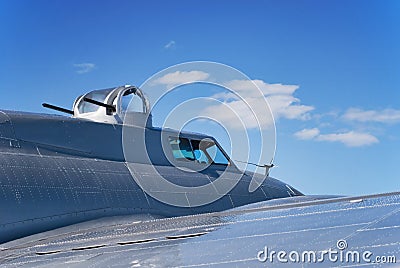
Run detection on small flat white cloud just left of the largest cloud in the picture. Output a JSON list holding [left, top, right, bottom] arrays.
[[153, 71, 210, 87]]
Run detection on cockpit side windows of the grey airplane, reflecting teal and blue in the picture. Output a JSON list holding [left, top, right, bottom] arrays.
[[169, 137, 229, 165]]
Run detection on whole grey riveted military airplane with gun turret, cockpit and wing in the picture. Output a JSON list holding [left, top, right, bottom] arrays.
[[0, 86, 400, 267]]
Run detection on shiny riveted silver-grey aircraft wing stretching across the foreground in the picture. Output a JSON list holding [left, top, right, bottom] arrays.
[[0, 193, 400, 267]]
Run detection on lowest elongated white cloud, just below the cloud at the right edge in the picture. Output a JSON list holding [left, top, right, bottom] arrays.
[[294, 128, 379, 147]]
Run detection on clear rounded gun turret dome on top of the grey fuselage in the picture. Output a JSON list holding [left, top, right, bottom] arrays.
[[73, 85, 152, 127]]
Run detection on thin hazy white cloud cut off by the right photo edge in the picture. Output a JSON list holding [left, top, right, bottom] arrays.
[[343, 108, 400, 123]]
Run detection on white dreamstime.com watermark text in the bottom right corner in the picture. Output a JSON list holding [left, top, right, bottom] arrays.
[[257, 239, 396, 264]]
